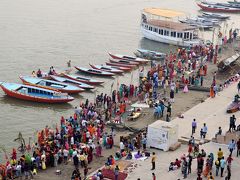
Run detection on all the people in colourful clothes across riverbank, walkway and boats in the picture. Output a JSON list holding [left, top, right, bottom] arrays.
[[0, 39, 240, 180]]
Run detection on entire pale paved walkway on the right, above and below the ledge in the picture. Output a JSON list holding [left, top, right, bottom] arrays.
[[127, 82, 240, 180]]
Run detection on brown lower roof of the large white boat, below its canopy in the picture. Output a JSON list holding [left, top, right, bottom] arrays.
[[147, 19, 196, 31]]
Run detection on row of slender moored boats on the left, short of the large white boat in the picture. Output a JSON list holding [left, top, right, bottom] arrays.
[[0, 50, 153, 103]]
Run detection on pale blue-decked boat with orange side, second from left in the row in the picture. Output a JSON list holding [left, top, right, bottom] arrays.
[[20, 77, 84, 94]]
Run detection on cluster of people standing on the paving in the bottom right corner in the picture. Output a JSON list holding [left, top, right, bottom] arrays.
[[169, 134, 240, 180]]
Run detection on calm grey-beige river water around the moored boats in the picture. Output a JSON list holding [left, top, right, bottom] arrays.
[[0, 0, 239, 158]]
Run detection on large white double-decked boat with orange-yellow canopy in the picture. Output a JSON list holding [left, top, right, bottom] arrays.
[[141, 8, 202, 47]]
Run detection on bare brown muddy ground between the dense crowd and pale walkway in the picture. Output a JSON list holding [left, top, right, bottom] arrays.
[[0, 41, 239, 180]]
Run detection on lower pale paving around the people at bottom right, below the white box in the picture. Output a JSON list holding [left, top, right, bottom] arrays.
[[127, 142, 240, 180]]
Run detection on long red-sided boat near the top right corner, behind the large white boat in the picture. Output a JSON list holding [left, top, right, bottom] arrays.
[[197, 3, 240, 13]]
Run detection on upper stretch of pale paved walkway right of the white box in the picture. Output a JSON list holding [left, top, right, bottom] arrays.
[[171, 82, 240, 140]]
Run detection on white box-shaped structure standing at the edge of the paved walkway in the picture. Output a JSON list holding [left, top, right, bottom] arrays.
[[147, 120, 178, 151]]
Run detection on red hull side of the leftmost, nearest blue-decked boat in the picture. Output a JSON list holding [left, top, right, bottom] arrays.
[[1, 86, 74, 103]]
